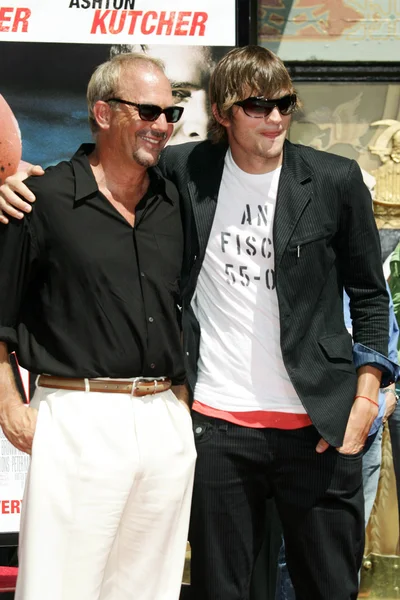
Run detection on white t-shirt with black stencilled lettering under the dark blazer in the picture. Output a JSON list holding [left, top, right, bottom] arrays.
[[192, 151, 305, 414]]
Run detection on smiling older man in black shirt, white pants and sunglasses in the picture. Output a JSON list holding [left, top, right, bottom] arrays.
[[0, 54, 196, 600]]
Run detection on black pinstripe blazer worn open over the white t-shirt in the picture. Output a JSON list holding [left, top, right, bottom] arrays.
[[160, 141, 388, 446]]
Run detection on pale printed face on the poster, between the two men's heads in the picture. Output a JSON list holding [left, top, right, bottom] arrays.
[[112, 46, 212, 144]]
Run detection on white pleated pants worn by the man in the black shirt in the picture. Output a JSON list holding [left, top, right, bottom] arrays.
[[15, 387, 196, 600]]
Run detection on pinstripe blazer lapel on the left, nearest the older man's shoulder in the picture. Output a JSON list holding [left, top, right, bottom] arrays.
[[188, 145, 226, 257]]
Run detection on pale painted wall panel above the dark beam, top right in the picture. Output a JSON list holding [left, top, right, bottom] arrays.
[[258, 0, 400, 61]]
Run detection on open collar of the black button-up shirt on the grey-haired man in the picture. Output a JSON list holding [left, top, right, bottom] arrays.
[[71, 144, 179, 204]]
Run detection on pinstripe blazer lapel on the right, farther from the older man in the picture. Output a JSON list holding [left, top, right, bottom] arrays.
[[273, 142, 312, 266]]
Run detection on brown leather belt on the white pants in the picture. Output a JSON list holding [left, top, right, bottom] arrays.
[[37, 375, 171, 396]]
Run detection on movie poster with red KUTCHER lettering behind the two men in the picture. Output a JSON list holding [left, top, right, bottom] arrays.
[[0, 0, 236, 533]]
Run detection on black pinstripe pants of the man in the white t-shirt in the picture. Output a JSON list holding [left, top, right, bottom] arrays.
[[189, 413, 364, 600]]
